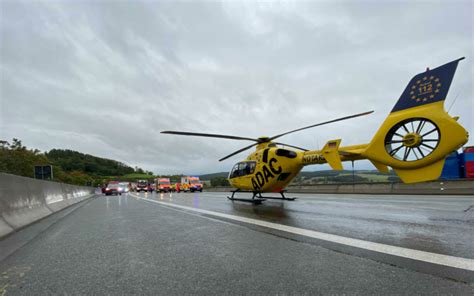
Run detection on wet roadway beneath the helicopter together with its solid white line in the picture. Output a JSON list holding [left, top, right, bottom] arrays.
[[134, 192, 474, 283]]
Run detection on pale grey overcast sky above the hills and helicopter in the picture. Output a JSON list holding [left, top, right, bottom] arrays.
[[0, 0, 474, 174]]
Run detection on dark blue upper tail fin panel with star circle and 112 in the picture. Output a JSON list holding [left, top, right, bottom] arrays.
[[392, 58, 464, 112]]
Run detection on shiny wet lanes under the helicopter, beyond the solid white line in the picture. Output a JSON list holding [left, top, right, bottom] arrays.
[[139, 192, 474, 259]]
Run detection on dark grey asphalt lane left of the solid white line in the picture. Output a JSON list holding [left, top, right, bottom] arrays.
[[0, 193, 474, 295]]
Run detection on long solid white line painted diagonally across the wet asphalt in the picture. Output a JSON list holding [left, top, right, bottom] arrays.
[[132, 194, 474, 271]]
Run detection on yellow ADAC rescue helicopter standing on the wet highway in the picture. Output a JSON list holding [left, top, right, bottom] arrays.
[[161, 58, 468, 203]]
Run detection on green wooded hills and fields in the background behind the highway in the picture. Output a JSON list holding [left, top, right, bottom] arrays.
[[0, 139, 399, 186]]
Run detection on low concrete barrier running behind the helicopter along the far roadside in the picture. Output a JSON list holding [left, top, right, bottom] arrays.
[[204, 179, 474, 196]]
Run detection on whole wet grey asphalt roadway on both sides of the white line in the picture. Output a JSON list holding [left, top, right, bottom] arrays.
[[0, 193, 474, 295]]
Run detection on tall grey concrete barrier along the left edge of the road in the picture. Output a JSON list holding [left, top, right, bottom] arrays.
[[0, 173, 94, 237]]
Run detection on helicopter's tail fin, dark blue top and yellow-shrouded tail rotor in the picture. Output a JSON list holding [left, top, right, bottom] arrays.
[[363, 58, 468, 183]]
